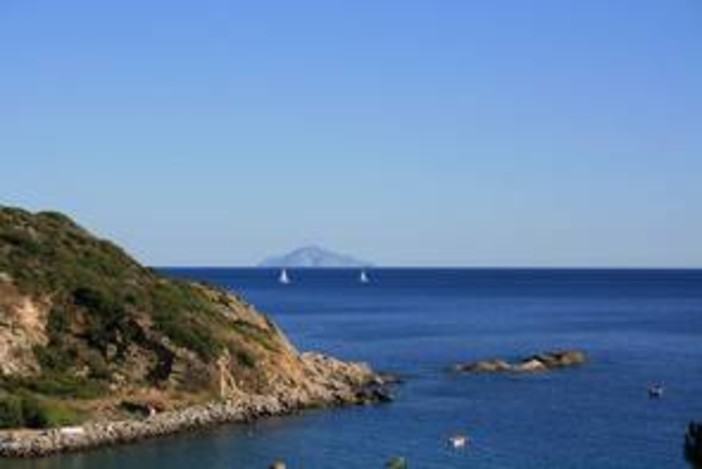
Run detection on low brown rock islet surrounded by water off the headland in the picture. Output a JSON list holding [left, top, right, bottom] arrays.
[[453, 350, 587, 373]]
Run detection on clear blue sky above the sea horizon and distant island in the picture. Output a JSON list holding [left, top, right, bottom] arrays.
[[0, 0, 702, 267]]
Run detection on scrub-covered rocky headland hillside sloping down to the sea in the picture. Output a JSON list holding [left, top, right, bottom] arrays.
[[0, 207, 374, 427]]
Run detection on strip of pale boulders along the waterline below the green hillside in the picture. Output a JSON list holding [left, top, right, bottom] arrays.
[[0, 382, 392, 458]]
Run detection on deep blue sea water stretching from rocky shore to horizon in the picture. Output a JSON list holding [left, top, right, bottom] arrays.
[[9, 269, 702, 469]]
